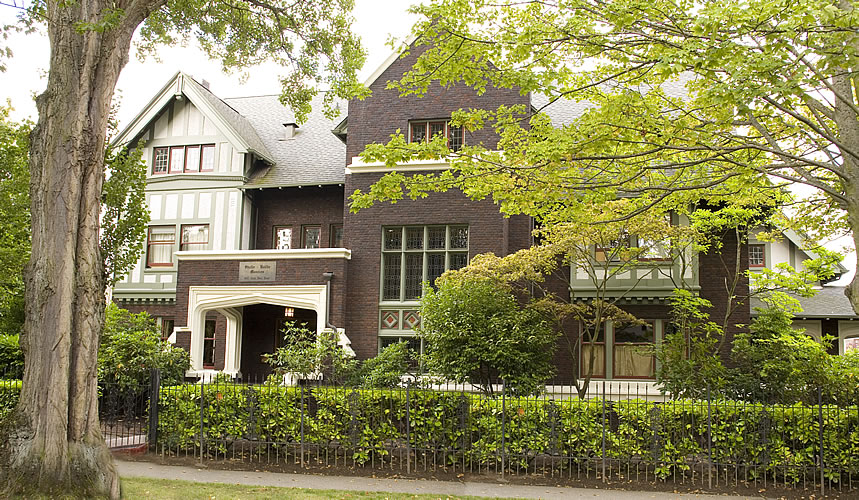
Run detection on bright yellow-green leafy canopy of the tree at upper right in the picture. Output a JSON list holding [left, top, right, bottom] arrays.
[[352, 0, 859, 311]]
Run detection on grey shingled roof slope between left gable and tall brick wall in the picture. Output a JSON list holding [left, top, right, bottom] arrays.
[[230, 95, 346, 188]]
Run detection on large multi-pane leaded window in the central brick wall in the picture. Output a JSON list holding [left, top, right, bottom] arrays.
[[381, 225, 468, 302]]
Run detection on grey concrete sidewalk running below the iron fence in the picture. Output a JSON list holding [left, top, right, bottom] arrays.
[[116, 459, 764, 500]]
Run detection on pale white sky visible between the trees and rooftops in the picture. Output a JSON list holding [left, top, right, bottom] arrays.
[[0, 0, 856, 284]]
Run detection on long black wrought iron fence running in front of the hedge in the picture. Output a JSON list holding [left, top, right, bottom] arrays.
[[151, 378, 859, 493]]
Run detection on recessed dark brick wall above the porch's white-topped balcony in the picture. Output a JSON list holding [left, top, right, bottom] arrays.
[[254, 186, 343, 249]]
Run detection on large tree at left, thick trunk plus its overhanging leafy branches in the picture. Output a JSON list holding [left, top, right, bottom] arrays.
[[0, 0, 364, 498]]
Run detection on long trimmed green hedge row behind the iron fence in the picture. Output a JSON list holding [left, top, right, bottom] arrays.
[[158, 385, 859, 481]]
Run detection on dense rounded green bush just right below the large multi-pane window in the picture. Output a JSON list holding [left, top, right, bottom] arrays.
[[420, 272, 558, 394]]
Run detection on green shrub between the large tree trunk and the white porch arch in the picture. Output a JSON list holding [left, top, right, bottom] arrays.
[[98, 304, 190, 390]]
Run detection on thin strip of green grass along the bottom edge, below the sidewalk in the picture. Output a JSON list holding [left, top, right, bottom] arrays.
[[122, 477, 498, 500]]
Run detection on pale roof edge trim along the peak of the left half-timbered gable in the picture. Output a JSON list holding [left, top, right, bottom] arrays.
[[113, 71, 275, 163]]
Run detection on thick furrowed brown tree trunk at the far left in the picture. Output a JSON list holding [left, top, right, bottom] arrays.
[[0, 0, 143, 498]]
